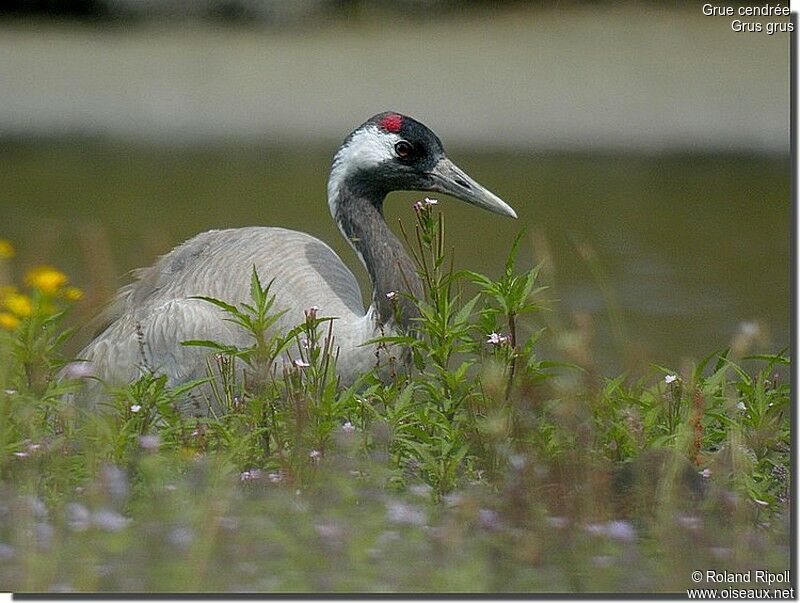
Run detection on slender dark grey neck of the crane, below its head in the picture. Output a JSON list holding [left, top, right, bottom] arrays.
[[331, 182, 422, 329]]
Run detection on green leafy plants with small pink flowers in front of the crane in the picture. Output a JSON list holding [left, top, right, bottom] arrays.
[[0, 203, 790, 592]]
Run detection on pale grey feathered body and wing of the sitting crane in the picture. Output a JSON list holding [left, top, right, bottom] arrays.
[[73, 227, 365, 392]]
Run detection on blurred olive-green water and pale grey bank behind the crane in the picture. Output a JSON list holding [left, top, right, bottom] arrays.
[[0, 0, 790, 367]]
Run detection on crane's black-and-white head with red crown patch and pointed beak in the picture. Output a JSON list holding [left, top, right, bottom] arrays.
[[328, 112, 517, 218]]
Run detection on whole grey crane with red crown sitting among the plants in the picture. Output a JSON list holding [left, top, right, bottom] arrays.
[[67, 112, 516, 412]]
